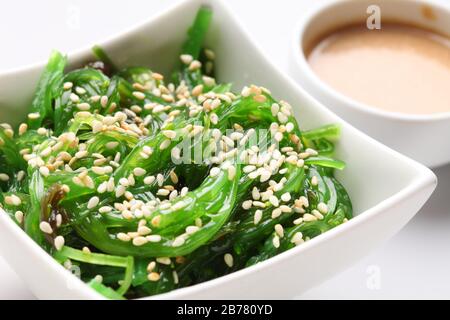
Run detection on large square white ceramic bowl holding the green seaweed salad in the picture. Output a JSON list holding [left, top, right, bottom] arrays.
[[0, 0, 436, 299]]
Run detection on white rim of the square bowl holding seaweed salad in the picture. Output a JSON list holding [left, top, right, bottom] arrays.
[[0, 0, 437, 299]]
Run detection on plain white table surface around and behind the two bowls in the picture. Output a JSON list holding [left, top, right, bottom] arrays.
[[0, 0, 450, 299]]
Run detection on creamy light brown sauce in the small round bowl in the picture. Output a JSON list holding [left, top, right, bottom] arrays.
[[308, 23, 450, 114]]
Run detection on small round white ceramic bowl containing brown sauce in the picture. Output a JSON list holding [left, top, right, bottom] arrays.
[[289, 0, 450, 167]]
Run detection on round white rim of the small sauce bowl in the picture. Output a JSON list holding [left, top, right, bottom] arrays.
[[290, 0, 450, 123]]
